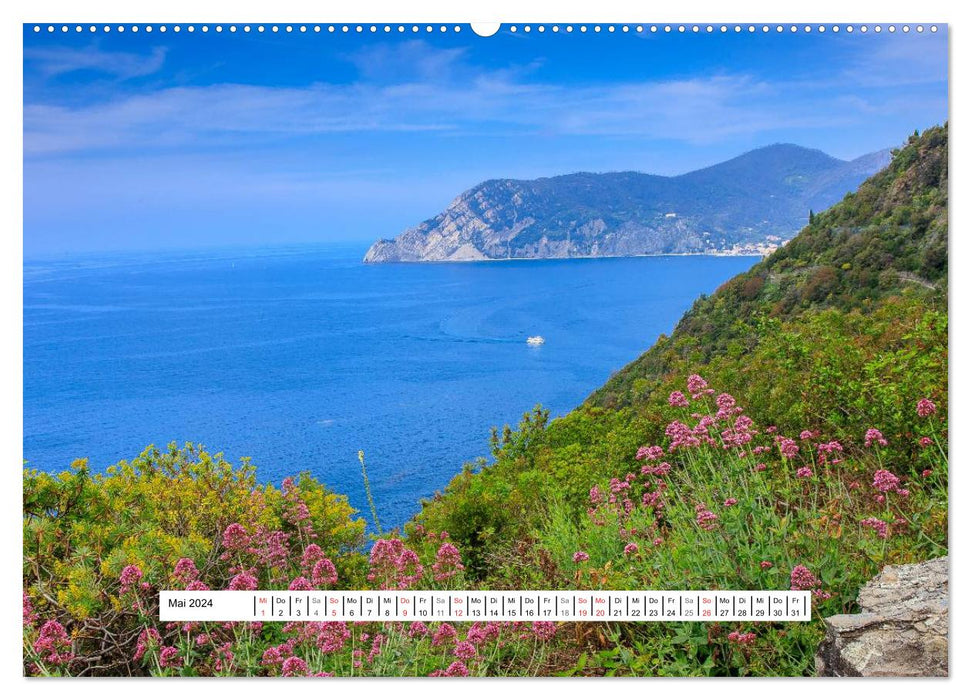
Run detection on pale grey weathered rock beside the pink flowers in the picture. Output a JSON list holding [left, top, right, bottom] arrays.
[[816, 557, 948, 676]]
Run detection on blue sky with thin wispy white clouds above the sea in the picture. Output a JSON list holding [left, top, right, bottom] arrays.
[[24, 26, 947, 257]]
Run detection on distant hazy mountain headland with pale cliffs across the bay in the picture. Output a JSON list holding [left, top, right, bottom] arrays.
[[364, 144, 890, 263]]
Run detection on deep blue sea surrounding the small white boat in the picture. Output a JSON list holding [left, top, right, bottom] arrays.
[[24, 245, 756, 526]]
